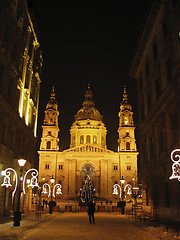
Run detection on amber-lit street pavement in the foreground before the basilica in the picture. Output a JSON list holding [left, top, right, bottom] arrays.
[[0, 213, 178, 240]]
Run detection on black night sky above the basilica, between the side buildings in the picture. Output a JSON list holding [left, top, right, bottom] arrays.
[[33, 0, 148, 151]]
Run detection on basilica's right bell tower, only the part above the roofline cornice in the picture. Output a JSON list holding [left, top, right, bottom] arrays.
[[118, 87, 137, 152]]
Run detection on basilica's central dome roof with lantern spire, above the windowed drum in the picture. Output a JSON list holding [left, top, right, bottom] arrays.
[[75, 84, 103, 121]]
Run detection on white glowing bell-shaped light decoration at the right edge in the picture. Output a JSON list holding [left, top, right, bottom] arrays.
[[169, 149, 180, 181]]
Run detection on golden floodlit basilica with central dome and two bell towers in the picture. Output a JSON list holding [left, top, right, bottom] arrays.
[[38, 85, 138, 200]]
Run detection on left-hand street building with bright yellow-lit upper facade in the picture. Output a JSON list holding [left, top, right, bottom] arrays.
[[0, 0, 42, 217]]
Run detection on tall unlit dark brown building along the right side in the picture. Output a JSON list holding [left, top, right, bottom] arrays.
[[130, 0, 180, 217]]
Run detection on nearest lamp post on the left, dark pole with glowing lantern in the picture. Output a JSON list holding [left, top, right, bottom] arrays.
[[13, 159, 26, 227]]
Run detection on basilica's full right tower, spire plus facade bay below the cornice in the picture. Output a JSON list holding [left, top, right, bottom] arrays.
[[118, 87, 139, 186]]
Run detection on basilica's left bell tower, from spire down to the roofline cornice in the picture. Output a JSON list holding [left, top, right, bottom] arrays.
[[40, 86, 59, 151]]
